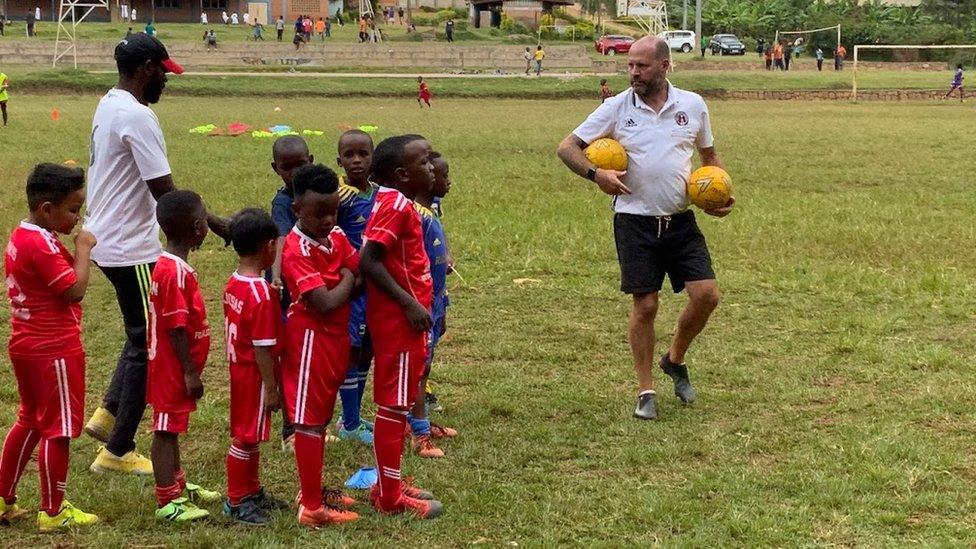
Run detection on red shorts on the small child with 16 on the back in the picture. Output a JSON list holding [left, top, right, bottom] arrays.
[[230, 363, 271, 444]]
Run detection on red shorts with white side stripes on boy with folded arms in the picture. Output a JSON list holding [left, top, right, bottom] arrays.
[[281, 321, 349, 425]]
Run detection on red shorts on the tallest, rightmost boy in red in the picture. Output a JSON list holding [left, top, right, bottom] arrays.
[[373, 347, 427, 409]]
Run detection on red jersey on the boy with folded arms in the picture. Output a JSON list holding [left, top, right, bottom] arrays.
[[281, 225, 359, 335]]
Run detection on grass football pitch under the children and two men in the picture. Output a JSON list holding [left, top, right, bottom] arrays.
[[0, 95, 976, 547]]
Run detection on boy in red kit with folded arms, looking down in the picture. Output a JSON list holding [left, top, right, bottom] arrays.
[[281, 164, 359, 528]]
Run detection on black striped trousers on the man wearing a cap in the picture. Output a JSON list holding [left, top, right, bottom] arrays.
[[99, 263, 156, 456]]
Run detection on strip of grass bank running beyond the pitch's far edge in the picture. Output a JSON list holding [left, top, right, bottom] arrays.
[[5, 67, 960, 102]]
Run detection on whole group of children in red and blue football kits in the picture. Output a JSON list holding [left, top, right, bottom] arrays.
[[0, 130, 457, 530]]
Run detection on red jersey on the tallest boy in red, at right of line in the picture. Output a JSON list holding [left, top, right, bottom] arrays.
[[363, 187, 434, 352]]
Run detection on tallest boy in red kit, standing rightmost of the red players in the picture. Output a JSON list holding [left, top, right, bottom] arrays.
[[362, 135, 443, 518]]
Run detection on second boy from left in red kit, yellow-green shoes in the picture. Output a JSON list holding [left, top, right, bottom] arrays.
[[146, 190, 220, 522]]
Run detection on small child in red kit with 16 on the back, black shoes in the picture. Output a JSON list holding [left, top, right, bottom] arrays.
[[224, 208, 288, 526]]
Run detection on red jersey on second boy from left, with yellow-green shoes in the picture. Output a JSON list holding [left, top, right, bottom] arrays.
[[146, 252, 210, 413]]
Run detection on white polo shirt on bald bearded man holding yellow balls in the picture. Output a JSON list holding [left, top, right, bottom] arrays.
[[573, 82, 714, 216]]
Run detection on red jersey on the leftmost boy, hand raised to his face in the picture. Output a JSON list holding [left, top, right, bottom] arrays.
[[5, 221, 82, 359]]
